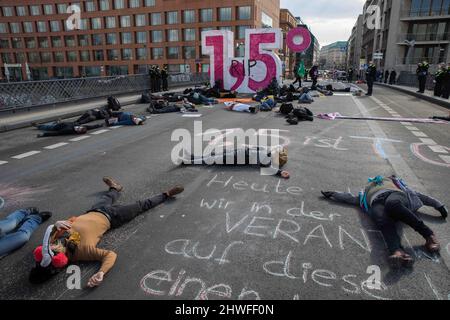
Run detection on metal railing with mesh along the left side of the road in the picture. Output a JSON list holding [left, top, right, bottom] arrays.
[[0, 73, 209, 112]]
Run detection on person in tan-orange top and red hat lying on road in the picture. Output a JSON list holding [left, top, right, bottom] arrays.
[[30, 177, 184, 287]]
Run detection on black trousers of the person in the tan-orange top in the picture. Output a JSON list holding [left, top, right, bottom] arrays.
[[90, 189, 168, 228]]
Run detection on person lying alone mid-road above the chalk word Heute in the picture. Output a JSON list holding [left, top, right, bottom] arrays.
[[182, 147, 289, 179]]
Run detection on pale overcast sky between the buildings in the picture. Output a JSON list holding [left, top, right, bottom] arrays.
[[281, 0, 365, 46]]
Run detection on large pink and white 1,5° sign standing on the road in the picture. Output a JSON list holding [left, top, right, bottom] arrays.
[[202, 27, 311, 93]]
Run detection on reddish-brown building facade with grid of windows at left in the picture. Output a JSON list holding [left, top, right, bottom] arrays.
[[0, 0, 280, 80]]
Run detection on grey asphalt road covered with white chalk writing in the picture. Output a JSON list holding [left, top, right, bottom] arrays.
[[0, 83, 450, 300]]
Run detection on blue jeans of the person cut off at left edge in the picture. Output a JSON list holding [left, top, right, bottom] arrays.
[[0, 209, 42, 257]]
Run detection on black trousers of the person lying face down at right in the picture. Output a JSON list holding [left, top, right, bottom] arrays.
[[370, 192, 433, 254]]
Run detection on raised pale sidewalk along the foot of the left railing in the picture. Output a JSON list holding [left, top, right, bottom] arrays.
[[0, 85, 195, 132]]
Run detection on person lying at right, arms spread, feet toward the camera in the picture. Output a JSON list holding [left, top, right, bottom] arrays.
[[322, 176, 448, 267]]
